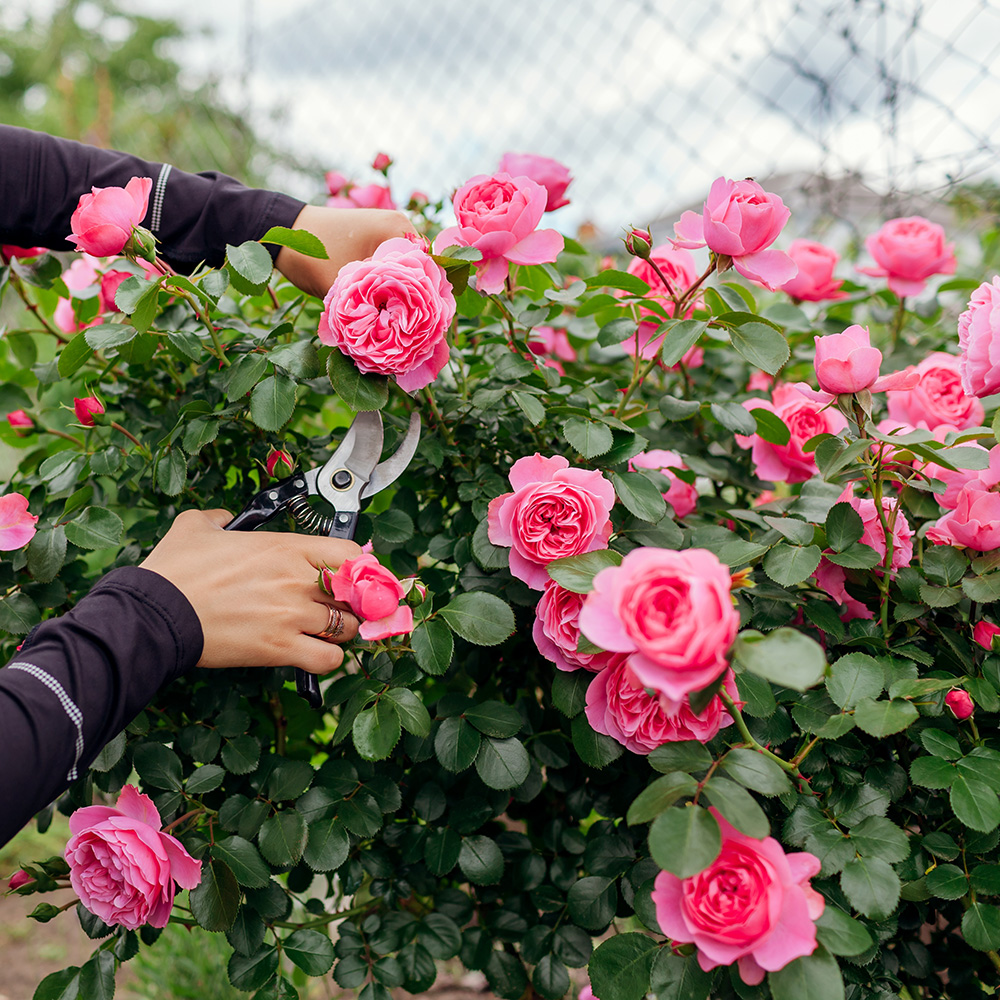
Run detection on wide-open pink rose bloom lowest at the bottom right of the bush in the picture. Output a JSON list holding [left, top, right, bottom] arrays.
[[653, 808, 825, 986]]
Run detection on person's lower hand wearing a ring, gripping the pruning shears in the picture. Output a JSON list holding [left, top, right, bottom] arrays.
[[140, 510, 361, 674]]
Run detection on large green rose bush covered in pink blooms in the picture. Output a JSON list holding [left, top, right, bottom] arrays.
[[0, 160, 1000, 1000]]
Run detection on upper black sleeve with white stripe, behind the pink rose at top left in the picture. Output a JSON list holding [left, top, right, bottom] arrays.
[[0, 125, 304, 271]]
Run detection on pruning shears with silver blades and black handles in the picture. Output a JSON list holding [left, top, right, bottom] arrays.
[[226, 410, 420, 708]]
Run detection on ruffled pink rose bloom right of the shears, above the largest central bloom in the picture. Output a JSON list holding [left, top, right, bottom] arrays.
[[487, 452, 615, 590]]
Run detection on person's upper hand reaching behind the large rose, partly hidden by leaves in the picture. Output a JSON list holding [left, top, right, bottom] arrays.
[[275, 205, 416, 298]]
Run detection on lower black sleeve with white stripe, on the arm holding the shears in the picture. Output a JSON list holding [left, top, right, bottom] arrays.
[[0, 566, 202, 846]]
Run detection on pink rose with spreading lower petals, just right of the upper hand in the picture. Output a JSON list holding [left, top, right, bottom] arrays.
[[434, 172, 563, 295]]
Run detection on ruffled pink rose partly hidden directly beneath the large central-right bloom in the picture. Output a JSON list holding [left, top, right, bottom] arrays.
[[586, 662, 737, 755]]
